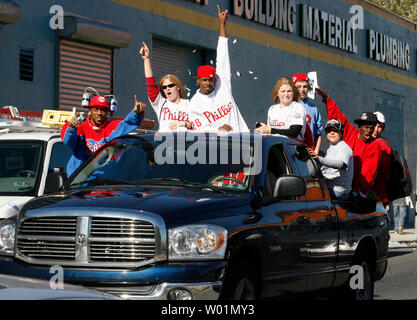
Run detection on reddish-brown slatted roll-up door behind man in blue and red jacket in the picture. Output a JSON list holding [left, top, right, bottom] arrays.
[[58, 39, 113, 110]]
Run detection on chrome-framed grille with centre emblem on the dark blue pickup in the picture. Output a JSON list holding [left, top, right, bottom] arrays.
[[16, 215, 161, 267]]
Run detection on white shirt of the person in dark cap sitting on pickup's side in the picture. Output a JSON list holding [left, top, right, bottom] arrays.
[[321, 140, 353, 193]]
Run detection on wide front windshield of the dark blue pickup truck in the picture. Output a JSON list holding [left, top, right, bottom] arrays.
[[66, 134, 260, 192]]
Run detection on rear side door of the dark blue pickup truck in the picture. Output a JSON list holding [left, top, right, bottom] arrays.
[[288, 145, 339, 291]]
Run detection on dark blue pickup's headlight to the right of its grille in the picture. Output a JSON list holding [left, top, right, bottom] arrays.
[[168, 225, 227, 260]]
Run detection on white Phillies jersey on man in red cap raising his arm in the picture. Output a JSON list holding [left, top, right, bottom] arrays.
[[190, 37, 249, 132]]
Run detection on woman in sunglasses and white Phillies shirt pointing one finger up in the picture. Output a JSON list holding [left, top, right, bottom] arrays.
[[139, 42, 191, 132]]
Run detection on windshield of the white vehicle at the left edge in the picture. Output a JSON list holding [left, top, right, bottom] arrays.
[[0, 140, 44, 196]]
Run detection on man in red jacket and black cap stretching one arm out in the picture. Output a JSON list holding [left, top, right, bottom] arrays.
[[317, 87, 389, 206]]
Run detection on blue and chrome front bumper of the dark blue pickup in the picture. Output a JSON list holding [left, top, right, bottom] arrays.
[[0, 257, 227, 300]]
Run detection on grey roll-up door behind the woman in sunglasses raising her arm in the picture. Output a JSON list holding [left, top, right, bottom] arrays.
[[151, 39, 211, 98]]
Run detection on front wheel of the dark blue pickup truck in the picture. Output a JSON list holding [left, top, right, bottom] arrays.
[[220, 261, 259, 300]]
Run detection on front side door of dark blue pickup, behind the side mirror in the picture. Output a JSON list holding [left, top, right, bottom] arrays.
[[262, 144, 308, 297]]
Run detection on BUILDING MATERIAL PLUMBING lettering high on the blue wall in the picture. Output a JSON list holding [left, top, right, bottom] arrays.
[[231, 0, 411, 70]]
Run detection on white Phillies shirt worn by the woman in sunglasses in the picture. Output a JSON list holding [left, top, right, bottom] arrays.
[[149, 93, 190, 132]]
